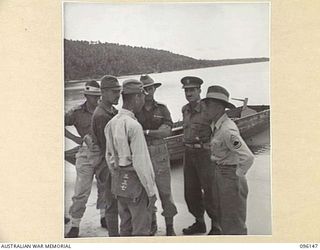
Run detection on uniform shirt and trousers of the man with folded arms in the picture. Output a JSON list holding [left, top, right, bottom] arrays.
[[137, 101, 177, 225]]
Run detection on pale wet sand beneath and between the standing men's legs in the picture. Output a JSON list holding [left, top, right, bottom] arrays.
[[65, 132, 271, 237]]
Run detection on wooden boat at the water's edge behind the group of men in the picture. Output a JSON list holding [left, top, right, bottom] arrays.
[[65, 98, 270, 165]]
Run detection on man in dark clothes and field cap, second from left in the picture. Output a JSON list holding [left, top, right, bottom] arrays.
[[87, 75, 121, 237]]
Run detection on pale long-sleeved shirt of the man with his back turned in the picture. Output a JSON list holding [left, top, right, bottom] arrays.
[[104, 109, 156, 197]]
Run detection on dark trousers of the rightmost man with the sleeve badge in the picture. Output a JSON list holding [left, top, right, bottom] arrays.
[[216, 165, 248, 235]]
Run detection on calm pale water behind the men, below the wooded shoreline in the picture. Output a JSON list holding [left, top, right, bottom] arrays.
[[65, 62, 269, 121]]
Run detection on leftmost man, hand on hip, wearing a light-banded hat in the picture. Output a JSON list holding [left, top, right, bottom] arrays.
[[65, 81, 104, 237]]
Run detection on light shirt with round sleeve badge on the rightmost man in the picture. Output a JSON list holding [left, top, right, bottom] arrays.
[[211, 114, 254, 175]]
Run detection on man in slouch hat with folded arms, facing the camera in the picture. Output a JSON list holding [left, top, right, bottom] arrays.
[[137, 75, 177, 236]]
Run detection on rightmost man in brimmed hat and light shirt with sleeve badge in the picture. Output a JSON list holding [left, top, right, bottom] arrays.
[[203, 85, 254, 235]]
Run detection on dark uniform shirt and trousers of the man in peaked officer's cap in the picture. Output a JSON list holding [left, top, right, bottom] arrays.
[[182, 101, 218, 223]]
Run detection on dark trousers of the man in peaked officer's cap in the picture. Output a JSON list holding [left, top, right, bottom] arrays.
[[184, 147, 218, 224]]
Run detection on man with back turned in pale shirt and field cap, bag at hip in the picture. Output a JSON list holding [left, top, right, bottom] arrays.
[[105, 79, 156, 236]]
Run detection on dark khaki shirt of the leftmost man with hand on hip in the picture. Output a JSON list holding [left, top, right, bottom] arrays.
[[64, 102, 92, 138]]
